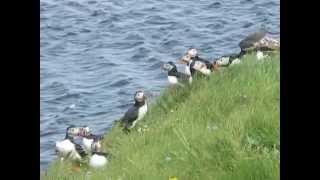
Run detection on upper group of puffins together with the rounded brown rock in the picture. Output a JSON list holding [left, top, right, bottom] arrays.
[[161, 32, 280, 86]]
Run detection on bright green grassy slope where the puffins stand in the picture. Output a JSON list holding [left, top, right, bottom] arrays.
[[43, 53, 280, 180]]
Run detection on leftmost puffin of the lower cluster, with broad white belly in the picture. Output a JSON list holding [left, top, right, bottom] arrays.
[[56, 127, 87, 161]]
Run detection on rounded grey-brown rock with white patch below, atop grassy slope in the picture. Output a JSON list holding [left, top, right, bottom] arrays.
[[239, 31, 280, 60]]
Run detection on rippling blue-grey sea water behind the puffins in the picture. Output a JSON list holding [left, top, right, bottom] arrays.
[[40, 0, 280, 169]]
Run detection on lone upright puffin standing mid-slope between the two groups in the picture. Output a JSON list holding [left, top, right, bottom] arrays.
[[121, 91, 148, 130]]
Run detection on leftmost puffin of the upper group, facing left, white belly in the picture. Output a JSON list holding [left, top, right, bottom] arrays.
[[161, 61, 192, 86]]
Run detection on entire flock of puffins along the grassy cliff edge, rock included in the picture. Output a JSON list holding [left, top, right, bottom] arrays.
[[56, 32, 280, 168]]
